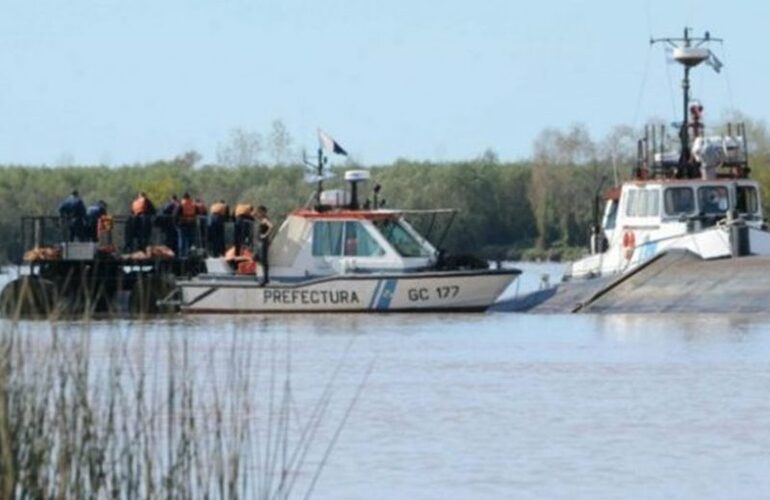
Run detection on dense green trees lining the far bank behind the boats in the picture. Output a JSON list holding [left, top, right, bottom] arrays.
[[0, 120, 770, 264]]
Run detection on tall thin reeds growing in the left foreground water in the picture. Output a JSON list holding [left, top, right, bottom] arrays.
[[0, 321, 371, 499]]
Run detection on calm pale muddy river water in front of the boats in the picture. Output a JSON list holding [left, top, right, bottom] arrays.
[[4, 265, 770, 499]]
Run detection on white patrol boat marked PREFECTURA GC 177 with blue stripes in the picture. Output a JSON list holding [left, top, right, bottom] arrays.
[[177, 152, 520, 313]]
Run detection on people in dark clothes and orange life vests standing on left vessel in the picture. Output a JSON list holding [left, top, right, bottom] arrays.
[[59, 190, 273, 282]]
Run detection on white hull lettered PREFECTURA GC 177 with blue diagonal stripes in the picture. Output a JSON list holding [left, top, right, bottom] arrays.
[[178, 269, 520, 313]]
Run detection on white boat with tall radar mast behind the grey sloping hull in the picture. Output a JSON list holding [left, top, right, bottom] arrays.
[[565, 30, 770, 280]]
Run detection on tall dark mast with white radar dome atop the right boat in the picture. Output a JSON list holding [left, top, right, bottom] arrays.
[[650, 27, 722, 177]]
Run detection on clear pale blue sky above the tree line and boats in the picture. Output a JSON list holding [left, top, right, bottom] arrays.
[[0, 0, 770, 165]]
